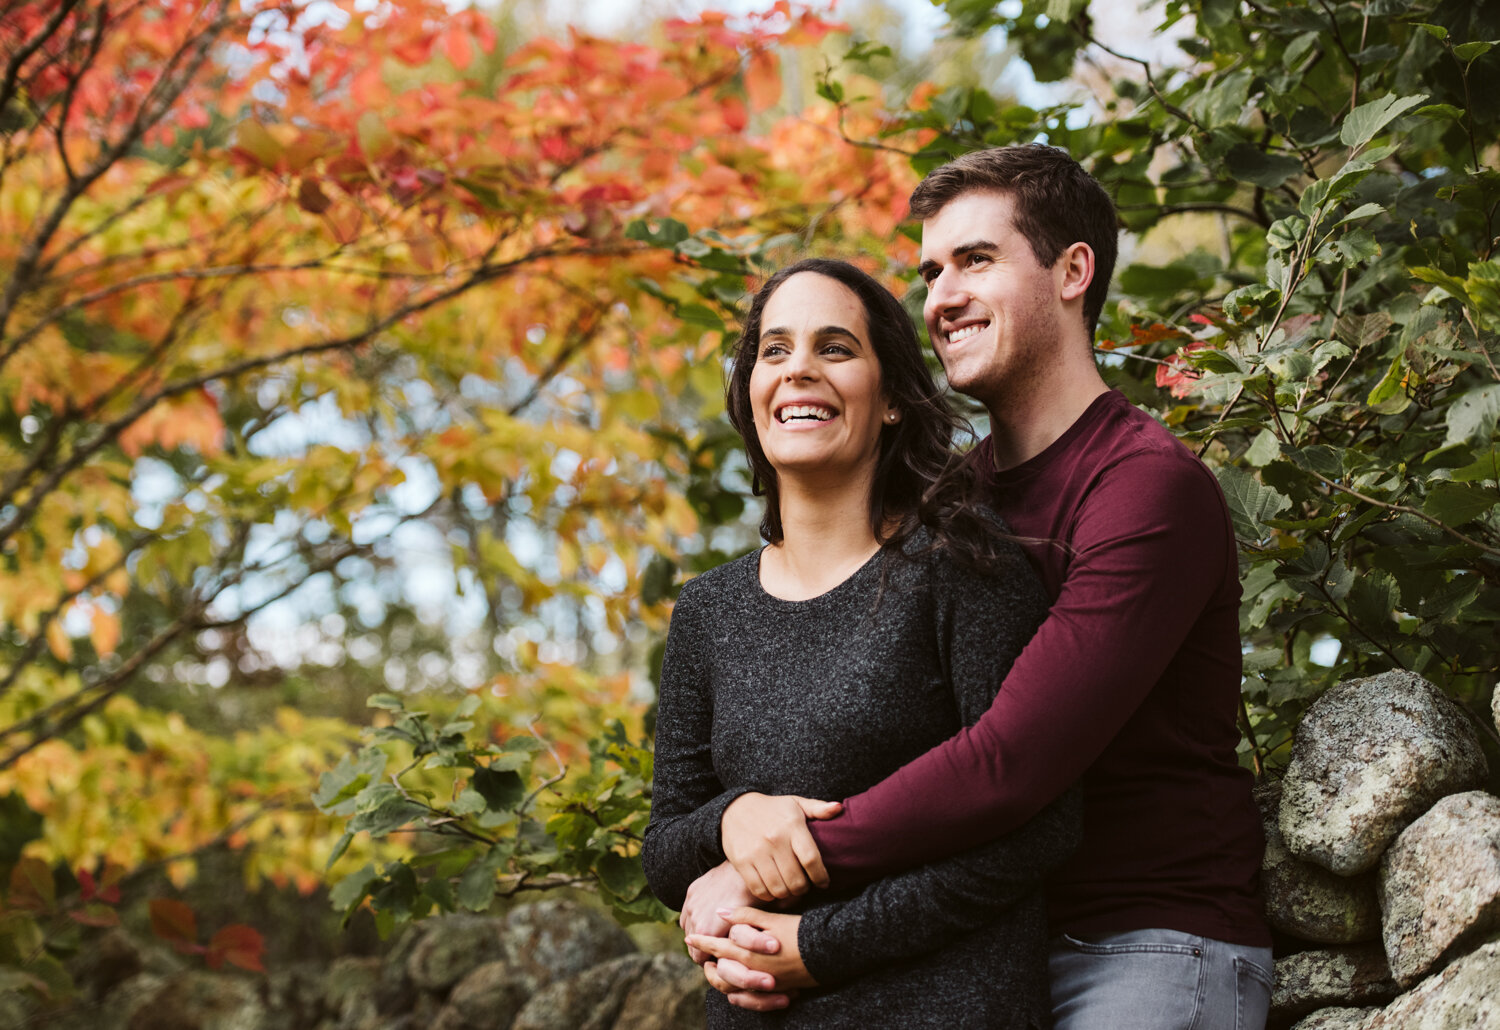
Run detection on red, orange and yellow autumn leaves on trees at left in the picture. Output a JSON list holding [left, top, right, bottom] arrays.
[[0, 0, 914, 1007]]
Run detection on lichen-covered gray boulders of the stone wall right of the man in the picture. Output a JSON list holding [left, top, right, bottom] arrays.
[[1256, 672, 1500, 1030]]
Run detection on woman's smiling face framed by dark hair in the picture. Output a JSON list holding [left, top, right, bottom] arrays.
[[750, 271, 890, 475]]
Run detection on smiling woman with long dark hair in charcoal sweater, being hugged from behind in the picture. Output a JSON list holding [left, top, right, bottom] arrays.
[[644, 259, 1079, 1027]]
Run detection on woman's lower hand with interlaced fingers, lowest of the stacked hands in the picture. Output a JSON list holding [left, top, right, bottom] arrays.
[[689, 909, 818, 1012]]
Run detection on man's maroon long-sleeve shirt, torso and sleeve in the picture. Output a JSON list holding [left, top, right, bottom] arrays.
[[812, 391, 1271, 946]]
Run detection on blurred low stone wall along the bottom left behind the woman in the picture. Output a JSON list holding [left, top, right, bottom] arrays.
[[41, 901, 704, 1030]]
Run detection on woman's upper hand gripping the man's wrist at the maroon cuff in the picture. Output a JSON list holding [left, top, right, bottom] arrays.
[[719, 793, 843, 901]]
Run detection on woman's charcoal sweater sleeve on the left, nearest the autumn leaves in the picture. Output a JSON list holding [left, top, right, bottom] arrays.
[[641, 583, 744, 909]]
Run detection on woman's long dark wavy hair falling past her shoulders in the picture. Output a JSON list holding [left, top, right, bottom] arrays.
[[725, 258, 1014, 570]]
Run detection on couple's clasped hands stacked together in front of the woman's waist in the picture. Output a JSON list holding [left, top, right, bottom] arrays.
[[678, 793, 843, 1012]]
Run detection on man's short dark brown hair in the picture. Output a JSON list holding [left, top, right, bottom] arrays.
[[911, 142, 1119, 339]]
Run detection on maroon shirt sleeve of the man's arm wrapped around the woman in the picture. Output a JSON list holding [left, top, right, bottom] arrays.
[[810, 451, 1235, 883]]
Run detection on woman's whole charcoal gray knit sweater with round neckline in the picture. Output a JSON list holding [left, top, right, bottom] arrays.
[[642, 537, 1080, 1029]]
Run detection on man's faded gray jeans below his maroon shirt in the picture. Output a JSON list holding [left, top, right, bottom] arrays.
[[1049, 930, 1271, 1030]]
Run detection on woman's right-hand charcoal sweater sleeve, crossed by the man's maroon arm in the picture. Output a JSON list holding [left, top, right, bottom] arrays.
[[798, 542, 1082, 987]]
